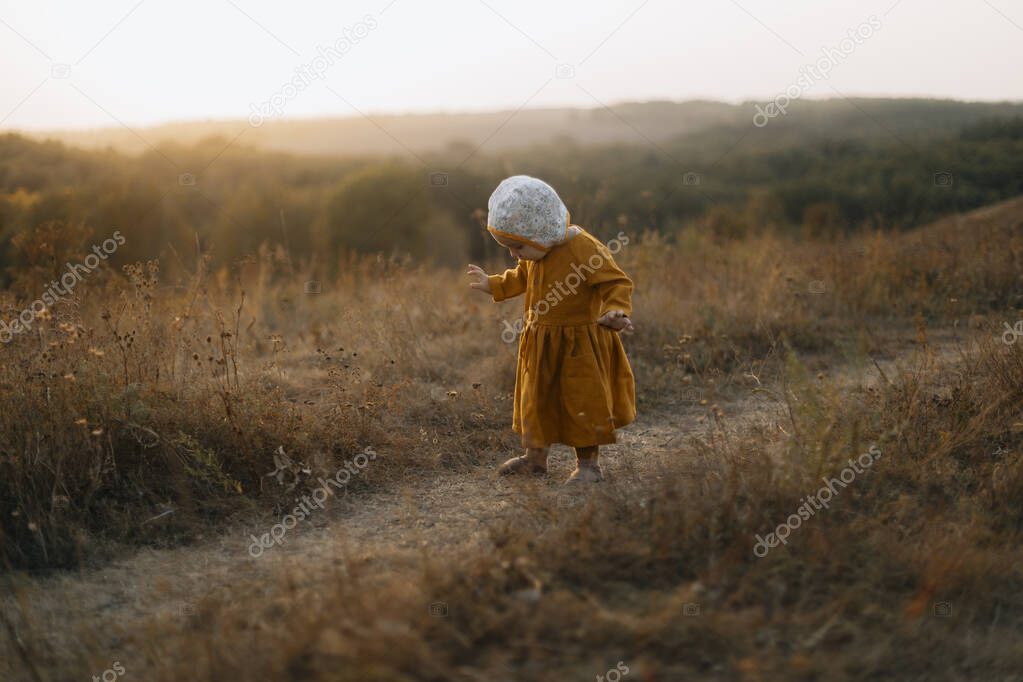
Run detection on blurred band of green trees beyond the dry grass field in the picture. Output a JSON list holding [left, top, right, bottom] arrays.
[[0, 111, 1023, 282]]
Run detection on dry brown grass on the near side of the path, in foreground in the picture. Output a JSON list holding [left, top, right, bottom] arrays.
[[9, 319, 1023, 681]]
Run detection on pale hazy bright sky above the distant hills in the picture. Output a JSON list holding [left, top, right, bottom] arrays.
[[0, 0, 1023, 129]]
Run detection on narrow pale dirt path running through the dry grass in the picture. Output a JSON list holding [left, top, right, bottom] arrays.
[[0, 327, 973, 679]]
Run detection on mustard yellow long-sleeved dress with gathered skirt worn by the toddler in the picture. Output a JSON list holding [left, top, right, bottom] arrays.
[[489, 228, 636, 448]]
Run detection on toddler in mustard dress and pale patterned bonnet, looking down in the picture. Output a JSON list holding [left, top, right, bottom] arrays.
[[469, 175, 635, 483]]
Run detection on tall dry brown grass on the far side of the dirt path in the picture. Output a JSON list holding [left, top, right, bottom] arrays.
[[0, 198, 1023, 569]]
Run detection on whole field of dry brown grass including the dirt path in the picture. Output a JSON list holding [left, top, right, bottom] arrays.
[[0, 194, 1023, 681]]
